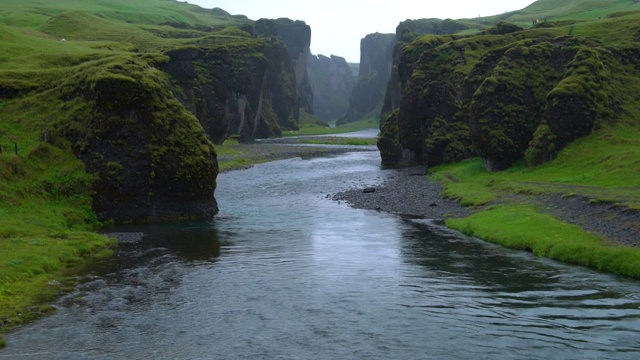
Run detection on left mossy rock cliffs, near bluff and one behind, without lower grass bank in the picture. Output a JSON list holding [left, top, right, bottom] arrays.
[[0, 0, 320, 222]]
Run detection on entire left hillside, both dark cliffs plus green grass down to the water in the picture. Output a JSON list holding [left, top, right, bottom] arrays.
[[0, 0, 311, 344]]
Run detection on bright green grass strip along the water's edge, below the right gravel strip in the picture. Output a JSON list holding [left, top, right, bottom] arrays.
[[447, 206, 640, 279]]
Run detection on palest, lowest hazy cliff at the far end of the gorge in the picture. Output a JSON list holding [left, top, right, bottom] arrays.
[[307, 55, 356, 122]]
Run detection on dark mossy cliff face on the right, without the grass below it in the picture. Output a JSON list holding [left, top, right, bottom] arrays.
[[379, 25, 618, 171]]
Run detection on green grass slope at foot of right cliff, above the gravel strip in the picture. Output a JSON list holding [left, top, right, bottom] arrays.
[[431, 123, 640, 209]]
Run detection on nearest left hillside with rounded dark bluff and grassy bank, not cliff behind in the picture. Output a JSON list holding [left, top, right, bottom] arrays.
[[0, 0, 264, 344]]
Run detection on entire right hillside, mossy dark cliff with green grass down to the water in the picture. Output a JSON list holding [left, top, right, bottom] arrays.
[[378, 0, 640, 277]]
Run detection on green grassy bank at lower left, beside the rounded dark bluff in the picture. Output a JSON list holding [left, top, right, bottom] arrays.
[[0, 143, 113, 346]]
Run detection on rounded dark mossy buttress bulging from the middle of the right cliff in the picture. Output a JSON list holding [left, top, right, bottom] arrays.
[[469, 40, 565, 170]]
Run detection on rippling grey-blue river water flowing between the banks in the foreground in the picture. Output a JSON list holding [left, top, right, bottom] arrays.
[[0, 152, 640, 359]]
